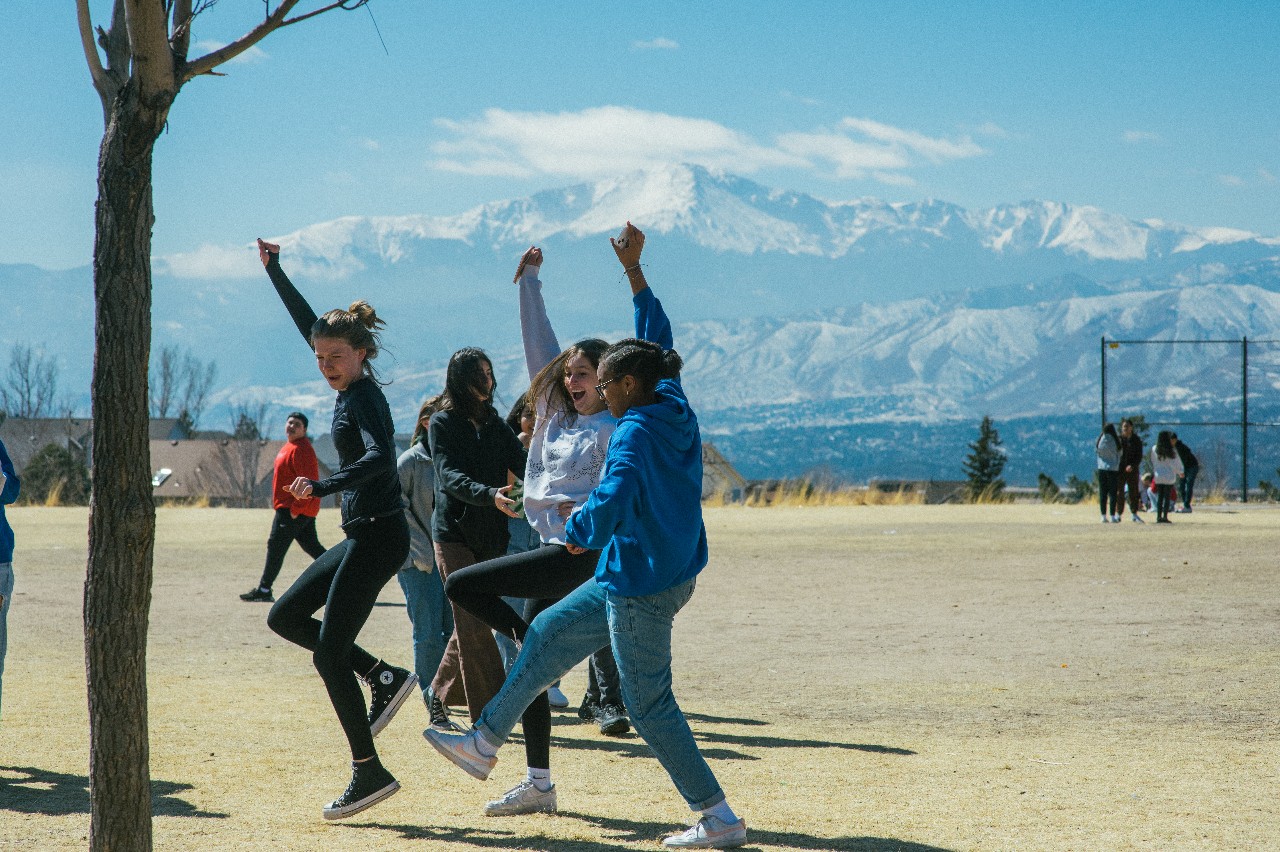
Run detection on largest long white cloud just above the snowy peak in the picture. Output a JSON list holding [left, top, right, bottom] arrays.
[[430, 106, 987, 185]]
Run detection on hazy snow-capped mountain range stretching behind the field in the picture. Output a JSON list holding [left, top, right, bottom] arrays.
[[10, 166, 1280, 478]]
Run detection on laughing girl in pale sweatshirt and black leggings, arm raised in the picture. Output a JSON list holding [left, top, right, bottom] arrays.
[[435, 246, 640, 816]]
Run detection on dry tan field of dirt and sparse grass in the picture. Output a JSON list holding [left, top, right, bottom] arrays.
[[0, 505, 1280, 852]]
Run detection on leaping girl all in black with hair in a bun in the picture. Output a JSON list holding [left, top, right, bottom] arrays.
[[257, 239, 417, 820]]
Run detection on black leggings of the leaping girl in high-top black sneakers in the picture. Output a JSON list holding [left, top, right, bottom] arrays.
[[266, 512, 408, 760]]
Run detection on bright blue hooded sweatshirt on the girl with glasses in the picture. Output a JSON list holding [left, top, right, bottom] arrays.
[[564, 288, 707, 597]]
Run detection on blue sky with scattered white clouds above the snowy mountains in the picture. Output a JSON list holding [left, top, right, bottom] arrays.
[[0, 0, 1280, 269]]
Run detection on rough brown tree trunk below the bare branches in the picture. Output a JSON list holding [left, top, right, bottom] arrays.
[[84, 76, 169, 851]]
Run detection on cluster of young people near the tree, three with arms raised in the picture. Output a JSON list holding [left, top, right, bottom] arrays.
[[242, 223, 746, 848]]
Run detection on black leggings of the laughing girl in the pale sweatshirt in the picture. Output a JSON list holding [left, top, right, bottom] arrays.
[[444, 545, 600, 769]]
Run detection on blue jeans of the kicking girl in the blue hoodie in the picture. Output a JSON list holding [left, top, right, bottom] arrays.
[[475, 580, 724, 811]]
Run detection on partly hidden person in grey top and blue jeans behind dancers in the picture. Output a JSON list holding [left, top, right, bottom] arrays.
[[396, 398, 456, 729]]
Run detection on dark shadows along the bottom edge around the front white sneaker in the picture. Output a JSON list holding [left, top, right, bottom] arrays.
[[346, 811, 950, 852]]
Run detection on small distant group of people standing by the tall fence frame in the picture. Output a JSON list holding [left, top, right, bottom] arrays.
[[1094, 418, 1199, 523]]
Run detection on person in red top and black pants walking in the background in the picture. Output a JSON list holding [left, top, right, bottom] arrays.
[[241, 411, 325, 603]]
